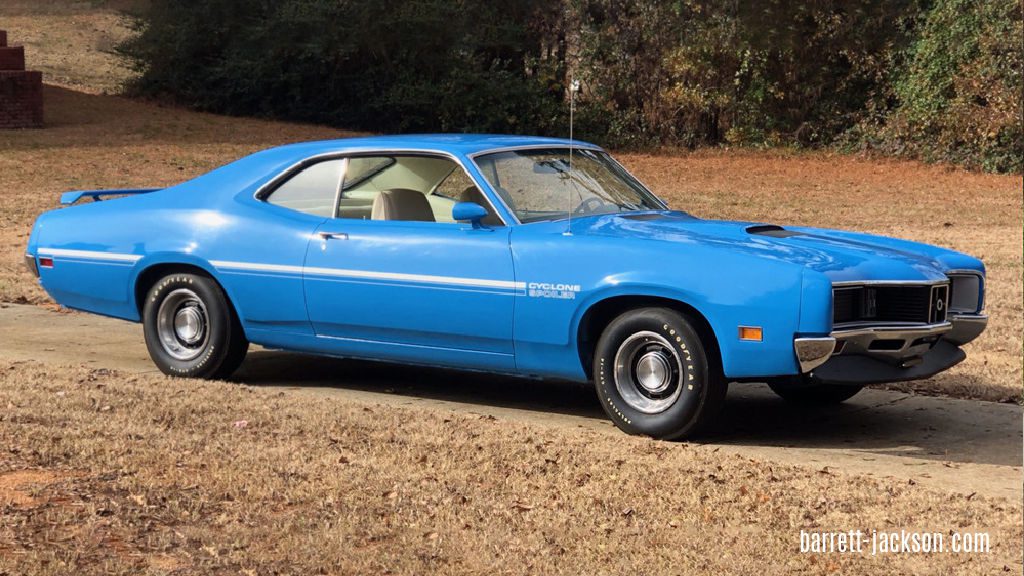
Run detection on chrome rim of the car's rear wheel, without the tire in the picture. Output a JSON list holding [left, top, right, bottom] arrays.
[[157, 288, 210, 362]]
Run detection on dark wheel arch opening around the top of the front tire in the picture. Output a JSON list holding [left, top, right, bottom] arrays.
[[575, 293, 723, 378]]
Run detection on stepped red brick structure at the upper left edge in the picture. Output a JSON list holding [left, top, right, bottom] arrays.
[[0, 30, 43, 129]]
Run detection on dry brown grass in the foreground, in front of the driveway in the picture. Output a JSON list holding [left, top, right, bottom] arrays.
[[0, 363, 1024, 574]]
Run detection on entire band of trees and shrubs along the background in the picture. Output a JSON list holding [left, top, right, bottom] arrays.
[[118, 0, 1024, 172]]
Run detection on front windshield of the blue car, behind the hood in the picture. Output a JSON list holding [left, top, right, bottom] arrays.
[[475, 148, 666, 223]]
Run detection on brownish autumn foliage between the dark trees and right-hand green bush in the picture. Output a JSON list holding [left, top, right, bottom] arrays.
[[574, 0, 919, 147]]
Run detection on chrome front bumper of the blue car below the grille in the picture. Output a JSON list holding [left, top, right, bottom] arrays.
[[793, 315, 988, 374]]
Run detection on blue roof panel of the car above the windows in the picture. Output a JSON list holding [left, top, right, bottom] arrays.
[[266, 134, 597, 157]]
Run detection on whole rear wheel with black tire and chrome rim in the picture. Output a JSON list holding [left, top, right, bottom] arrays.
[[142, 273, 249, 379]]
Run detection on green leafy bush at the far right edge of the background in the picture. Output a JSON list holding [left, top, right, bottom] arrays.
[[851, 0, 1024, 172]]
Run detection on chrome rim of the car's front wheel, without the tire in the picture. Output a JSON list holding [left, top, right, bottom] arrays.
[[614, 331, 683, 414]]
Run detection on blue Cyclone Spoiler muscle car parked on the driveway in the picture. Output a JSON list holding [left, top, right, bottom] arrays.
[[26, 134, 987, 438]]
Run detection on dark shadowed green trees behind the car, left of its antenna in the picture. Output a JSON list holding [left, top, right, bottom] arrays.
[[119, 0, 561, 131]]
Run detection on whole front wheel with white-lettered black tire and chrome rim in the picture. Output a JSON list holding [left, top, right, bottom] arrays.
[[594, 307, 728, 440]]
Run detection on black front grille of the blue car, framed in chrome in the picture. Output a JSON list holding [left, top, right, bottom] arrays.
[[833, 284, 949, 326]]
